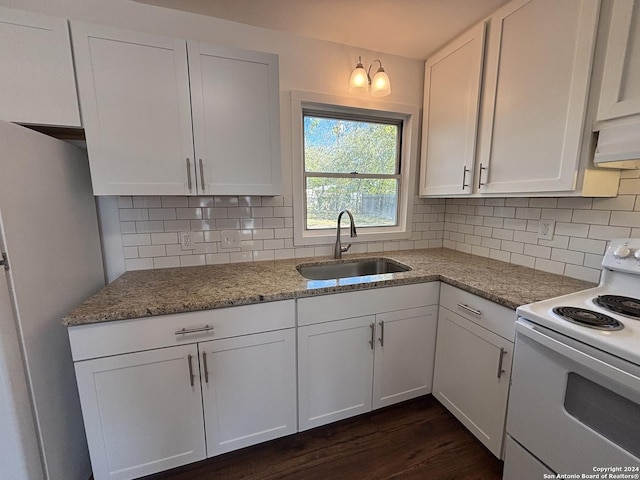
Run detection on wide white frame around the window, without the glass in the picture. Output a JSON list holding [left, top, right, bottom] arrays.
[[291, 91, 419, 246]]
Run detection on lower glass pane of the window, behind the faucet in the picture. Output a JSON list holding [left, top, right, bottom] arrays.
[[306, 177, 399, 229]]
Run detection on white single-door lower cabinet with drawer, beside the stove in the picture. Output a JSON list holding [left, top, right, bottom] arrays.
[[433, 285, 516, 458]]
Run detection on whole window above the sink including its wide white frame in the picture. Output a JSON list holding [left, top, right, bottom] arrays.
[[292, 92, 418, 245]]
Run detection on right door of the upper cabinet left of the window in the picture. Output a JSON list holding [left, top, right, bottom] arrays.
[[188, 42, 281, 195]]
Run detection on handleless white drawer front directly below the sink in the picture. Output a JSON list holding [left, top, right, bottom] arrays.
[[298, 282, 440, 326]]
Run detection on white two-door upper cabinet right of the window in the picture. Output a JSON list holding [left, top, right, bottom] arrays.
[[420, 0, 619, 196]]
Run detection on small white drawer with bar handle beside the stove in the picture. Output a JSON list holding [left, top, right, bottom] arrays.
[[440, 283, 516, 341]]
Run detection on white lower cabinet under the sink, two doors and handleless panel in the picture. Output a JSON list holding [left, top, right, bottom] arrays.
[[298, 282, 439, 431]]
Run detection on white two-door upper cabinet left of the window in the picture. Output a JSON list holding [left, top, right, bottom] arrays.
[[72, 23, 280, 195]]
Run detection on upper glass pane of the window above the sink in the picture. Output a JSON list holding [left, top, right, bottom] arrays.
[[304, 114, 400, 175]]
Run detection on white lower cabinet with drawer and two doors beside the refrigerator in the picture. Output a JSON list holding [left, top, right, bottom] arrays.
[[70, 301, 297, 480]]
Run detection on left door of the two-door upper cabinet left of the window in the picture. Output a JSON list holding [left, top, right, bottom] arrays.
[[71, 23, 196, 195]]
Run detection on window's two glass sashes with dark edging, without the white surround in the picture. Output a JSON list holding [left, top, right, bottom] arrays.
[[303, 110, 402, 230]]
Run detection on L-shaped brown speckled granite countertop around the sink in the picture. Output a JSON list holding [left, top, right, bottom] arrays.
[[62, 248, 594, 326]]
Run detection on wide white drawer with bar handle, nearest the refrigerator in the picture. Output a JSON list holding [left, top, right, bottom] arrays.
[[69, 300, 295, 361]]
